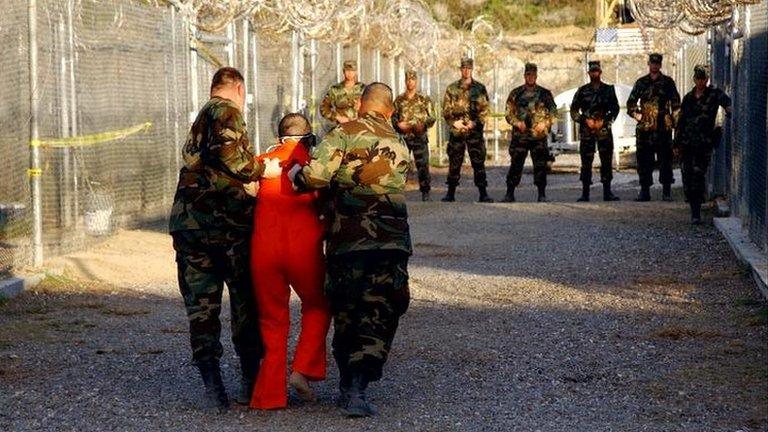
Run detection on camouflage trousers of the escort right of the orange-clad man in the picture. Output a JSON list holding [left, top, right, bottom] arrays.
[[325, 251, 410, 382]]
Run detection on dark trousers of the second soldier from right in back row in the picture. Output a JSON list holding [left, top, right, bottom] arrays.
[[636, 131, 675, 186]]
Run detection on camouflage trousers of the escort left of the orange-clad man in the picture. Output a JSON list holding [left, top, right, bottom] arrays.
[[171, 230, 262, 364]]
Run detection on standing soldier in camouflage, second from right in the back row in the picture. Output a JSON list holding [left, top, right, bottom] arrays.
[[627, 53, 680, 201]]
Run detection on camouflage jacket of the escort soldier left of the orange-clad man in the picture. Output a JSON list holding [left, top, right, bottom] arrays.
[[169, 97, 264, 232]]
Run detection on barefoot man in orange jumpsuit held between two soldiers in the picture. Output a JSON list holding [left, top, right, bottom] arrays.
[[250, 114, 331, 409]]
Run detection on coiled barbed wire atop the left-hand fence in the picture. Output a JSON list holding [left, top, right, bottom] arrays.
[[161, 0, 501, 72]]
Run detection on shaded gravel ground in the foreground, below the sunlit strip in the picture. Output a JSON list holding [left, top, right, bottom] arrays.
[[0, 278, 768, 431]]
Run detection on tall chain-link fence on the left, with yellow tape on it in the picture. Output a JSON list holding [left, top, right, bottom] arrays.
[[0, 0, 450, 273]]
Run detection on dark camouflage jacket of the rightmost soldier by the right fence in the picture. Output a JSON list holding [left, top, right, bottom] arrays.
[[675, 85, 731, 150]]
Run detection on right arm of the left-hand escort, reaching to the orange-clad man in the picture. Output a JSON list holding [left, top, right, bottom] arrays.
[[200, 107, 264, 183]]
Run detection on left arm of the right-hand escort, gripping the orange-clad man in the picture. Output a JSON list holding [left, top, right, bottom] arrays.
[[291, 128, 346, 191]]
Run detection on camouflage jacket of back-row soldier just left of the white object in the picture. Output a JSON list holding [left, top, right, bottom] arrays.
[[504, 85, 557, 141]]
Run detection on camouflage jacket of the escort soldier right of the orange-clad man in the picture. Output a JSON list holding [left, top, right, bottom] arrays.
[[294, 112, 411, 256]]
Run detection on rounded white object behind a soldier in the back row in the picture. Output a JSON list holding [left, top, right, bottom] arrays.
[[549, 84, 637, 166]]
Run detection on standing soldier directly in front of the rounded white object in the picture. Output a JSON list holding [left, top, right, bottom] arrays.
[[571, 61, 619, 201]]
